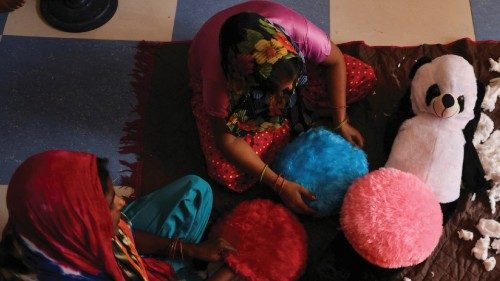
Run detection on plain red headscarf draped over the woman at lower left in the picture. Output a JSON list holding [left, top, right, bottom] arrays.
[[7, 150, 124, 280]]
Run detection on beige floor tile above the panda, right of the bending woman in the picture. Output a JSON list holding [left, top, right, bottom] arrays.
[[330, 0, 475, 46]]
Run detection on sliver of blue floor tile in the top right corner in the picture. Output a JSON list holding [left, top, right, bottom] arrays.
[[470, 0, 500, 41]]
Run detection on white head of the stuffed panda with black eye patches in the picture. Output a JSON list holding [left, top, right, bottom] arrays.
[[410, 55, 477, 126]]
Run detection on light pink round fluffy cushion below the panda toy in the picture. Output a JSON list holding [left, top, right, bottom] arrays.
[[340, 168, 443, 268]]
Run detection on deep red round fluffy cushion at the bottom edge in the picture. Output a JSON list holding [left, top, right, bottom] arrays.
[[212, 199, 307, 281]]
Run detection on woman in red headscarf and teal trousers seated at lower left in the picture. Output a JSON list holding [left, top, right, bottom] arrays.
[[0, 150, 234, 281]]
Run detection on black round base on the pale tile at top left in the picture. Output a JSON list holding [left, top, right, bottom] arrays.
[[40, 0, 118, 32]]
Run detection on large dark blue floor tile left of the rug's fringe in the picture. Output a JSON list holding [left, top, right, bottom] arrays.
[[0, 35, 137, 184]]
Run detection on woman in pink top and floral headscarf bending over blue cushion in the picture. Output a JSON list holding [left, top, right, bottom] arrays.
[[189, 1, 376, 214]]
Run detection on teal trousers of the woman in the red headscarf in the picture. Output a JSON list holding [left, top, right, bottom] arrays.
[[123, 175, 213, 272]]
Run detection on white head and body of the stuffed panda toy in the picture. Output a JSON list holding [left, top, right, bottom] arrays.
[[385, 55, 478, 203]]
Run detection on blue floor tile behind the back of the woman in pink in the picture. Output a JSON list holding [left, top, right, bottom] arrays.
[[172, 0, 330, 41]]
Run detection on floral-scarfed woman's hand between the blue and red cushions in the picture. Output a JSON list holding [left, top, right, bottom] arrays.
[[278, 179, 316, 215]]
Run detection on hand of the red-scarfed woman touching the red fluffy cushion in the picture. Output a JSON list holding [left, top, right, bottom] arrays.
[[185, 238, 236, 262]]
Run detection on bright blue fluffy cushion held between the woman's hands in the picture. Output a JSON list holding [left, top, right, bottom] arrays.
[[273, 128, 368, 216]]
